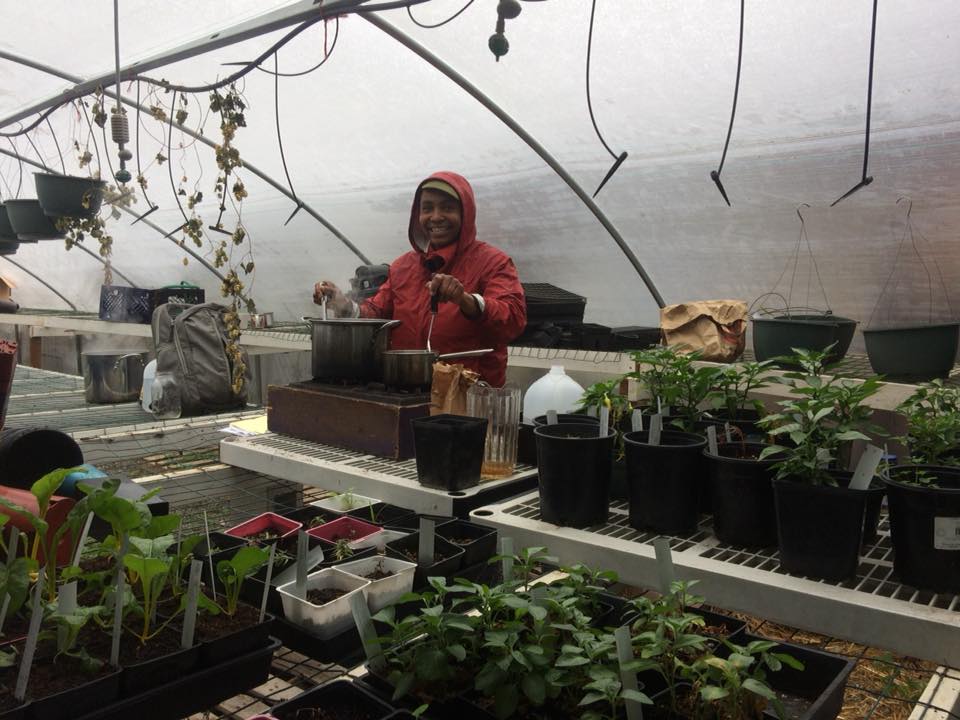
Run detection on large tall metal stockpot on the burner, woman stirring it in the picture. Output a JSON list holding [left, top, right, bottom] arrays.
[[303, 317, 400, 382]]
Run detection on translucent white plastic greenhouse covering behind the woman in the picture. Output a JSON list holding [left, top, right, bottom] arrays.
[[0, 0, 960, 343]]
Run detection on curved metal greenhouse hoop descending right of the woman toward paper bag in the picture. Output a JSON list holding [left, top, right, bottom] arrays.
[[360, 13, 666, 307]]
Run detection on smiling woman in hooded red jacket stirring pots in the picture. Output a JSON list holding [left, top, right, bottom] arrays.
[[313, 172, 527, 387]]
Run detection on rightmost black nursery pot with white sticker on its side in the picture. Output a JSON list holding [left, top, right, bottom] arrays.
[[884, 465, 960, 593]]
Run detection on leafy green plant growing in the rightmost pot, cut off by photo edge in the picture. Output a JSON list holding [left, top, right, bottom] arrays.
[[897, 380, 960, 465]]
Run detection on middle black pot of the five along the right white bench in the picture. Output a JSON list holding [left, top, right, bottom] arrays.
[[703, 442, 777, 547]]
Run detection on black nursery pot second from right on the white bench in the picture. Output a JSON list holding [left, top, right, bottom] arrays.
[[773, 480, 867, 580]]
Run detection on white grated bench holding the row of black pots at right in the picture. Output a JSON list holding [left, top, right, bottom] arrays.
[[471, 492, 960, 667]]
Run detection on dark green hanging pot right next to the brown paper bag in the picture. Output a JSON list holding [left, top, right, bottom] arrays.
[[750, 315, 857, 363]]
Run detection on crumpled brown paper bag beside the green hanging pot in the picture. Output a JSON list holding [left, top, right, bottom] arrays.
[[660, 300, 747, 362]]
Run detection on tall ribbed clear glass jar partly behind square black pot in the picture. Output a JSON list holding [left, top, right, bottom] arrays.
[[467, 382, 520, 479]]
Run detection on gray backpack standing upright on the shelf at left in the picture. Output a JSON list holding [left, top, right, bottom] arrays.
[[152, 303, 249, 415]]
